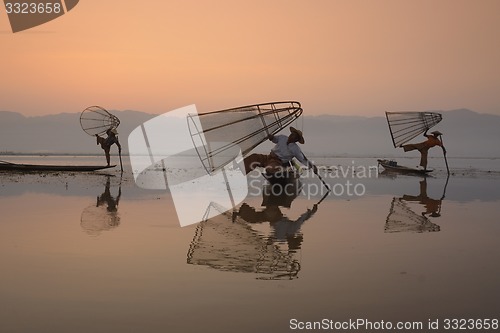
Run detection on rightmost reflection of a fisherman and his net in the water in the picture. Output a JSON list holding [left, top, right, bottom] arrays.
[[384, 177, 449, 233]]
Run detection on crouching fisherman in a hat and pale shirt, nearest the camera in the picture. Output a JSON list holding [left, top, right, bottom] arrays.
[[243, 127, 318, 174]]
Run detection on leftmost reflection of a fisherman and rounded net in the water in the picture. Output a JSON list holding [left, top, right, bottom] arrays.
[[80, 175, 122, 236]]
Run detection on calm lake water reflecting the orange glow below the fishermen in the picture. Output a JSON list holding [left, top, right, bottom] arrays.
[[0, 156, 500, 333]]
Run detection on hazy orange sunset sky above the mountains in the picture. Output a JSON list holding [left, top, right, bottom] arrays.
[[0, 0, 500, 116]]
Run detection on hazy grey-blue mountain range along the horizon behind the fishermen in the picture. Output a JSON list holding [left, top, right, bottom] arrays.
[[0, 109, 500, 157]]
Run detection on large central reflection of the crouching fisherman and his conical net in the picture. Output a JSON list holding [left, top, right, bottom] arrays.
[[187, 180, 318, 280]]
